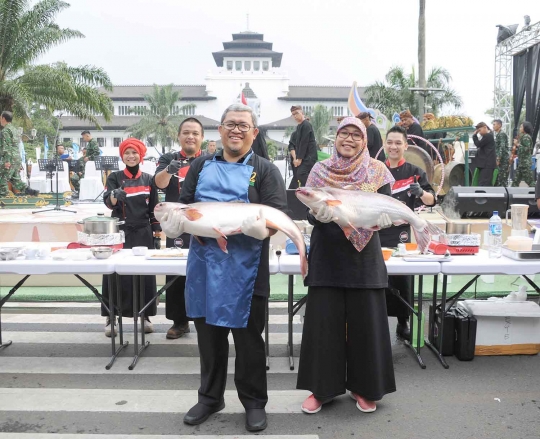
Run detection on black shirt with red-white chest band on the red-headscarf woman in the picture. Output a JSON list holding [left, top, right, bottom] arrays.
[[103, 169, 161, 231]]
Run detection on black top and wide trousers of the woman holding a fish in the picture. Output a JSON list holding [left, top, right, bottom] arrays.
[[296, 185, 396, 401]]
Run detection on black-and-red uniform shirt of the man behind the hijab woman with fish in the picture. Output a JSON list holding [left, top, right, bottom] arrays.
[[379, 160, 435, 247]]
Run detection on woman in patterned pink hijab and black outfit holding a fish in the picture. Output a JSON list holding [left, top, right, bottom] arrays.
[[297, 117, 396, 413]]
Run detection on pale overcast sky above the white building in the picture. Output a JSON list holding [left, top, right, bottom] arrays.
[[40, 0, 540, 121]]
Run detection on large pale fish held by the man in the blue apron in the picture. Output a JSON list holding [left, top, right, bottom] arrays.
[[154, 202, 307, 277]]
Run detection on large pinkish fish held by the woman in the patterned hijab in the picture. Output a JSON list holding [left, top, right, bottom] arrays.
[[296, 187, 443, 253]]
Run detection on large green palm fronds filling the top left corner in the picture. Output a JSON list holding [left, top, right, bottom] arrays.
[[0, 0, 113, 127]]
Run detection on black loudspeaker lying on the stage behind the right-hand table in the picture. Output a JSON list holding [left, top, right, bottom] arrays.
[[441, 186, 508, 218]]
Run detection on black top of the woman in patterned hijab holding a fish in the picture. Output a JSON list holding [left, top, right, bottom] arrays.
[[304, 184, 391, 289]]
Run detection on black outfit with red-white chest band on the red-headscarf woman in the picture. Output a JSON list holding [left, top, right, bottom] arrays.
[[101, 166, 161, 317]]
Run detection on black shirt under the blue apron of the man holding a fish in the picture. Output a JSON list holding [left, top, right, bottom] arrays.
[[179, 150, 288, 297]]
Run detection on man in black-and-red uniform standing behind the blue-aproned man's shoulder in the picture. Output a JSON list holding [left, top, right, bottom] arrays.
[[155, 117, 204, 339]]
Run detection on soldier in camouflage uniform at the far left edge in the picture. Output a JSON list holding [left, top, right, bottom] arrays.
[[0, 111, 39, 197]]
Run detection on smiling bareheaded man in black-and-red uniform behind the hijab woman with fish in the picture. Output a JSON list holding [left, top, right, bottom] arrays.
[[379, 125, 436, 339]]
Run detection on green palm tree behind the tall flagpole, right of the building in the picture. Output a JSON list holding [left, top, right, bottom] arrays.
[[365, 67, 463, 119]]
